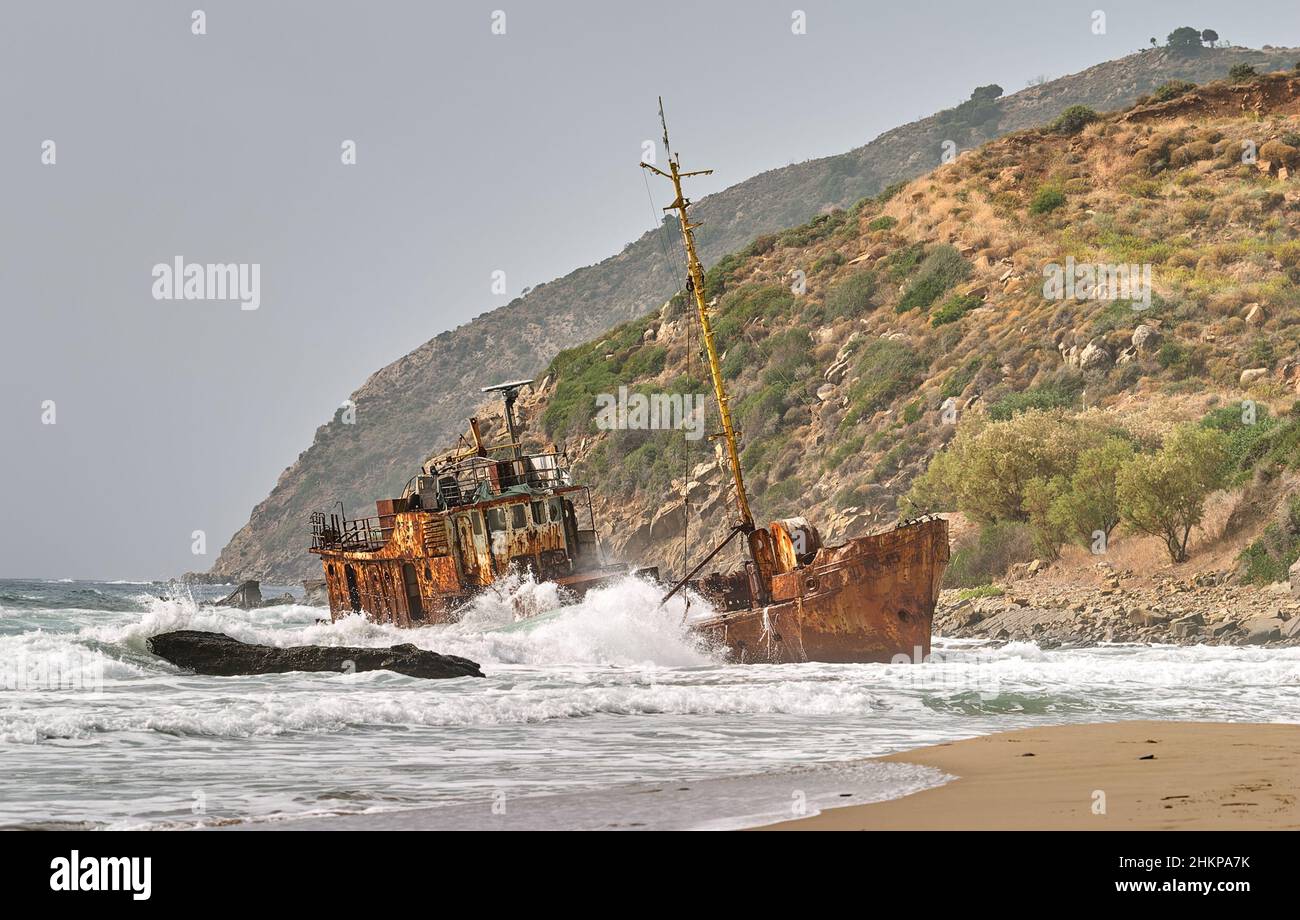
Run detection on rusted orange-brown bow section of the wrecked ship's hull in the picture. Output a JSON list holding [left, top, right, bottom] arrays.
[[693, 518, 949, 664]]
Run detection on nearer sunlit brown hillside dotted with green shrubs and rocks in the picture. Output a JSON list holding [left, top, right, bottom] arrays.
[[509, 71, 1300, 585]]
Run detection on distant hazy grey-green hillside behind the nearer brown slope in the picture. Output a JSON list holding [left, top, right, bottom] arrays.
[[213, 48, 1300, 581]]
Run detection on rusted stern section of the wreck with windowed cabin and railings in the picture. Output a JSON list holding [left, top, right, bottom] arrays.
[[311, 431, 627, 626]]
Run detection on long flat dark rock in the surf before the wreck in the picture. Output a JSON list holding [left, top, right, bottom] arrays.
[[148, 629, 484, 678]]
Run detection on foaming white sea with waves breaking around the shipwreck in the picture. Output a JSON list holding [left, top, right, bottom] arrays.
[[0, 577, 1300, 829]]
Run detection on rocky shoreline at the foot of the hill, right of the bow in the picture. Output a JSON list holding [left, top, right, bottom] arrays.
[[933, 563, 1300, 648]]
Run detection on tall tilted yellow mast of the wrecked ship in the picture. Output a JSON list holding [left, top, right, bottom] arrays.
[[641, 96, 771, 599]]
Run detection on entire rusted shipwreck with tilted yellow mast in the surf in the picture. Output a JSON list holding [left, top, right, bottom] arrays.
[[311, 104, 949, 663]]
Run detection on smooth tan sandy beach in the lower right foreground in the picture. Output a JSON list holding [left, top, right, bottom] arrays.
[[762, 721, 1300, 830]]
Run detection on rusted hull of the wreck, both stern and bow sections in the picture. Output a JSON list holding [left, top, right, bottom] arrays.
[[320, 513, 949, 663]]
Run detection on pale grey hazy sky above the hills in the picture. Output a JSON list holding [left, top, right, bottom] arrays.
[[0, 0, 1300, 578]]
